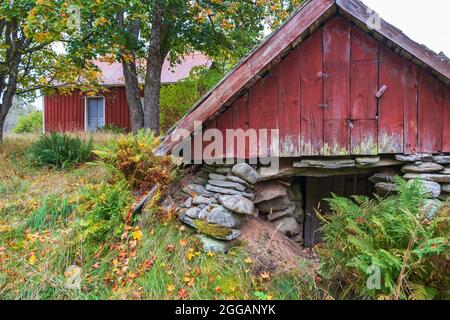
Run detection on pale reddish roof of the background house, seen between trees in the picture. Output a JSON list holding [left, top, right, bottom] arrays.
[[94, 53, 211, 86]]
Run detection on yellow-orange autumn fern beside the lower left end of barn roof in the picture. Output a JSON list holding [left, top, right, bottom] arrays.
[[93, 130, 171, 191]]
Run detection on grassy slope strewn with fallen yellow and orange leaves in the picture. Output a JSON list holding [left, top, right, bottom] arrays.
[[0, 135, 318, 299]]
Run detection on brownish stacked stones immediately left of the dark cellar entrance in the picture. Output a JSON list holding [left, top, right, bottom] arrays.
[[254, 180, 304, 242]]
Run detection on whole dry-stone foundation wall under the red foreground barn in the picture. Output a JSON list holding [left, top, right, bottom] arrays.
[[178, 154, 450, 251]]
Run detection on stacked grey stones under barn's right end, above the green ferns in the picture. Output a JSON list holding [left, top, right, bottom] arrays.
[[370, 154, 450, 201]]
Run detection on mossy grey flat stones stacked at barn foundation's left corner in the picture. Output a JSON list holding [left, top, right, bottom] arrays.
[[180, 163, 258, 251]]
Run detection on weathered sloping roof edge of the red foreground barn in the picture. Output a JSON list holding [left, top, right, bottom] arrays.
[[158, 0, 450, 154]]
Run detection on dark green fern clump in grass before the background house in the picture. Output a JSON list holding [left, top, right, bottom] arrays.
[[29, 133, 93, 169]]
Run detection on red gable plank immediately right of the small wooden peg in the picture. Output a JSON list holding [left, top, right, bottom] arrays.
[[378, 45, 404, 154]]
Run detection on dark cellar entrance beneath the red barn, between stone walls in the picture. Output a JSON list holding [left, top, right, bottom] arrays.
[[296, 173, 375, 247]]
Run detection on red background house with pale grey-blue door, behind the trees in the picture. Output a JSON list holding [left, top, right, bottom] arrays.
[[44, 54, 210, 132]]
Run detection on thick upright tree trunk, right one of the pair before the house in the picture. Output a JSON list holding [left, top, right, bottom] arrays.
[[144, 7, 167, 135]]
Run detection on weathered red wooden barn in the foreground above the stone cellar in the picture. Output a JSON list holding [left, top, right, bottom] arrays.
[[159, 0, 450, 245]]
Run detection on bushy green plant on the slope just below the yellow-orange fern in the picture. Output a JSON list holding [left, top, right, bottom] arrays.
[[79, 181, 133, 242]]
